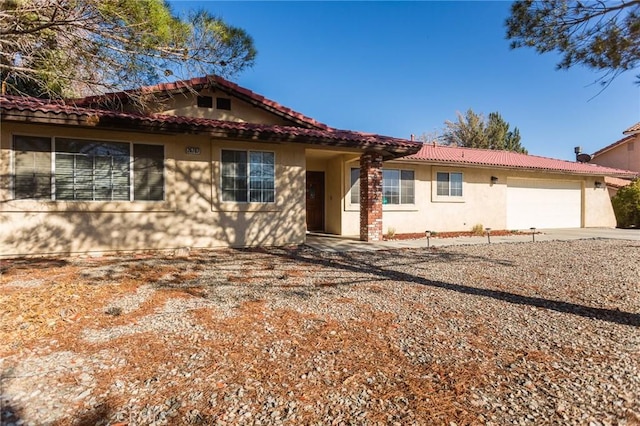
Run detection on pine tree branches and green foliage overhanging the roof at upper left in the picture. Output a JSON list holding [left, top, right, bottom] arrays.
[[0, 0, 256, 98]]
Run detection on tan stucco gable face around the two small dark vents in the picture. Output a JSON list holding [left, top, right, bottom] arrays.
[[160, 90, 291, 125]]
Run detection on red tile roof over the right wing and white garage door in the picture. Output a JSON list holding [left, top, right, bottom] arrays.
[[400, 144, 637, 177]]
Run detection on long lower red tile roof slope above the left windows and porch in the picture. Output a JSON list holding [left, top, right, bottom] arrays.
[[0, 96, 421, 157]]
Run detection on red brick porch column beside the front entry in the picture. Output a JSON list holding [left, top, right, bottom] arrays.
[[360, 152, 382, 241]]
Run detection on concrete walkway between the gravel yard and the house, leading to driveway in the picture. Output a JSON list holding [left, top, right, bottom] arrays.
[[305, 228, 640, 252]]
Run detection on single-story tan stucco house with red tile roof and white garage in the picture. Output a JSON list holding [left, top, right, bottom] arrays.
[[0, 77, 633, 256]]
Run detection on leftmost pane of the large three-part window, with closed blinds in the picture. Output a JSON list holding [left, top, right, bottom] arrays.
[[13, 136, 51, 200]]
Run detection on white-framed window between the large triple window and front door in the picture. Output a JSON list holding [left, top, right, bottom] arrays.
[[221, 150, 275, 203]]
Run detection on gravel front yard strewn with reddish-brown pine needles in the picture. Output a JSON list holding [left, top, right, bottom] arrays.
[[0, 240, 640, 426]]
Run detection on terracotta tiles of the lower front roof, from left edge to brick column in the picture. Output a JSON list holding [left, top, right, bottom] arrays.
[[0, 96, 421, 154]]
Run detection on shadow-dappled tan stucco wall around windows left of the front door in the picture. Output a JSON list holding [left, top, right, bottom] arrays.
[[0, 122, 305, 256]]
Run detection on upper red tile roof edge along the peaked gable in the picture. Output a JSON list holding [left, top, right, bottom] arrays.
[[69, 75, 330, 129]]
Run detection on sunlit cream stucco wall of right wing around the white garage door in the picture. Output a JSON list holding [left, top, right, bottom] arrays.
[[342, 161, 615, 235]]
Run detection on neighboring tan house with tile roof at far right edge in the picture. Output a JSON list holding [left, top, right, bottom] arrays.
[[591, 123, 640, 197]]
